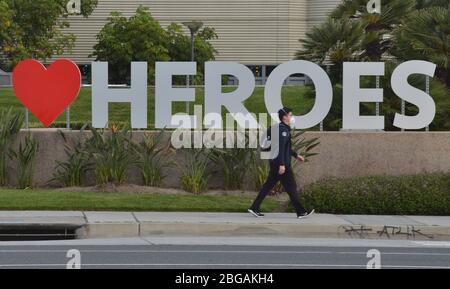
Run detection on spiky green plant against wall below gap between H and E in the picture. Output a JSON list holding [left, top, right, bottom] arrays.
[[133, 130, 173, 187]]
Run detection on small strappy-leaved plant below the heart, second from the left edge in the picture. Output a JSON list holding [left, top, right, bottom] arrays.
[[10, 134, 39, 189]]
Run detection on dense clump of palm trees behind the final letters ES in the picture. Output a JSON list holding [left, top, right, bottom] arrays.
[[296, 0, 450, 130]]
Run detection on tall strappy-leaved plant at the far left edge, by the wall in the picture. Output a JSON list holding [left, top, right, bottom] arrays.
[[0, 108, 24, 186]]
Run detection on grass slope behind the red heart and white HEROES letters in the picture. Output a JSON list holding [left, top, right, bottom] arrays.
[[0, 86, 314, 128]]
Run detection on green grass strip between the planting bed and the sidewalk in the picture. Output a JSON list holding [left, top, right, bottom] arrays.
[[0, 189, 279, 212]]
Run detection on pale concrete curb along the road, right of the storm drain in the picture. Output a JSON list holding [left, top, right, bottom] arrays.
[[75, 223, 450, 241]]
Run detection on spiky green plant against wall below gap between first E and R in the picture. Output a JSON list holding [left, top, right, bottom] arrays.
[[180, 149, 210, 194]]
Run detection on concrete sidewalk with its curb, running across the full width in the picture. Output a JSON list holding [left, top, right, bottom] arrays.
[[0, 211, 450, 240]]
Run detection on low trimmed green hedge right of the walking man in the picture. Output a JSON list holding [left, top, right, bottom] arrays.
[[300, 173, 450, 215]]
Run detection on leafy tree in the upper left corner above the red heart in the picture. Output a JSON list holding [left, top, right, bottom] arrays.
[[0, 0, 98, 69]]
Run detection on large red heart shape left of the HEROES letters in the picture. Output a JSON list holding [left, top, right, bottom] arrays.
[[13, 59, 81, 127]]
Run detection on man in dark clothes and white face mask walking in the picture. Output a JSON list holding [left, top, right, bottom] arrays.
[[248, 107, 314, 219]]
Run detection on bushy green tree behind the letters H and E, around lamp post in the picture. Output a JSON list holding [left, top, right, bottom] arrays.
[[92, 6, 217, 83]]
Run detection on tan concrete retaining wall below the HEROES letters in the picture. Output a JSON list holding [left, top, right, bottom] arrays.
[[10, 129, 450, 188]]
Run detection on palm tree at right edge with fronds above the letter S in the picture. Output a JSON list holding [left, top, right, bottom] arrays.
[[393, 5, 450, 87]]
